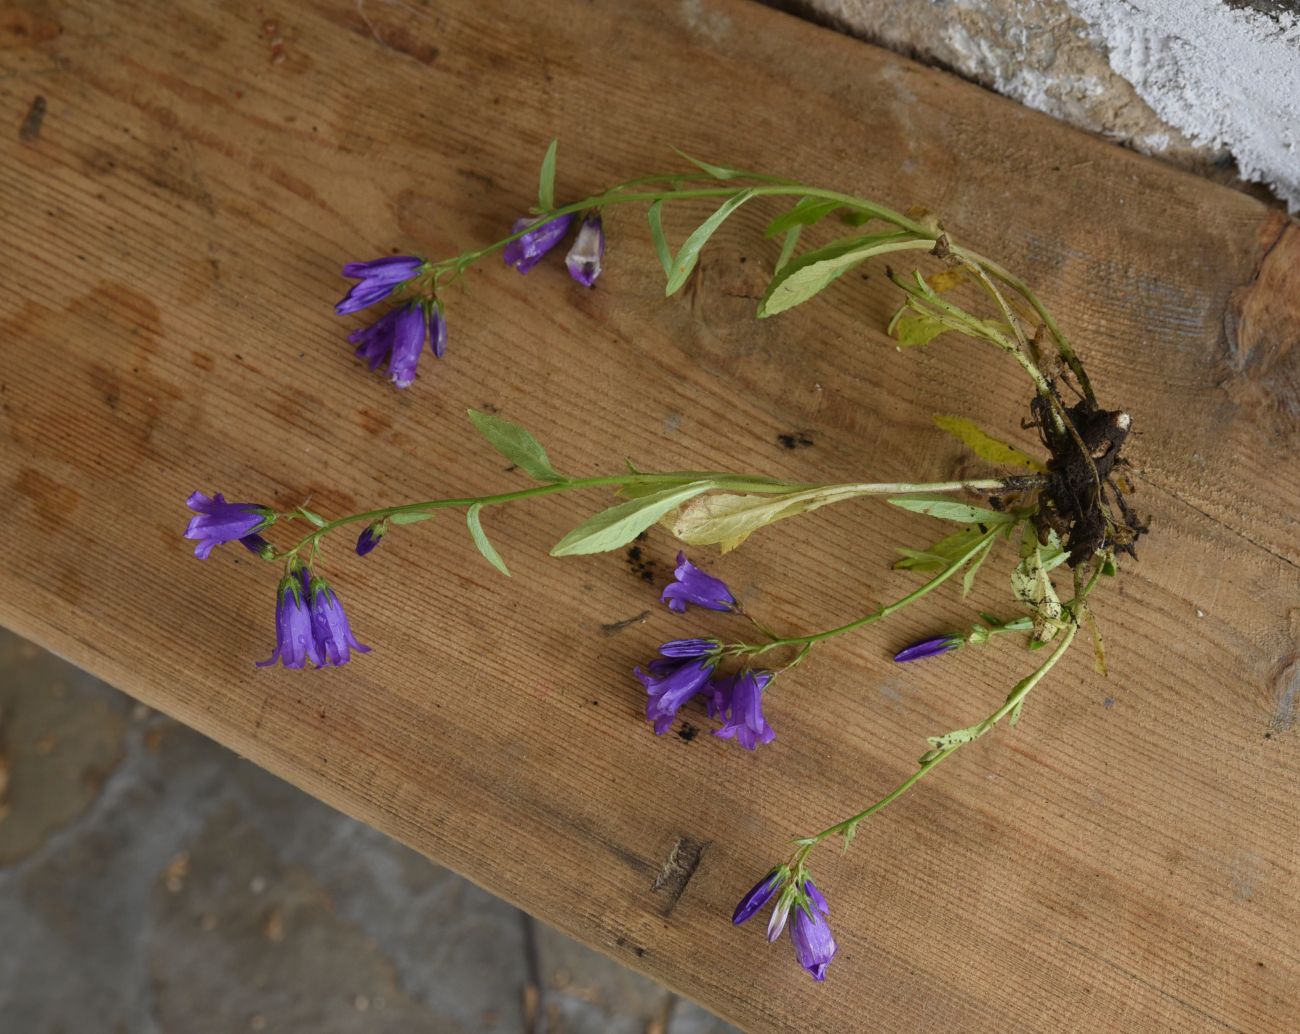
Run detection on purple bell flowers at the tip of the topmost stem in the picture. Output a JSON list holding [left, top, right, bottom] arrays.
[[334, 255, 447, 388]]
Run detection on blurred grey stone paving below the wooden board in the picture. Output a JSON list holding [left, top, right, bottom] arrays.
[[0, 630, 735, 1034]]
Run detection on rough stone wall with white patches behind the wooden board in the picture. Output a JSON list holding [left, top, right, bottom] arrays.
[[775, 0, 1300, 212]]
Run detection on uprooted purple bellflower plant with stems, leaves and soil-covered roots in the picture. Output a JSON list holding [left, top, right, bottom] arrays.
[[185, 142, 1147, 981]]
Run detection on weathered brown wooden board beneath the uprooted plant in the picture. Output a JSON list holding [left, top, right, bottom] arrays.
[[0, 0, 1300, 1031]]
